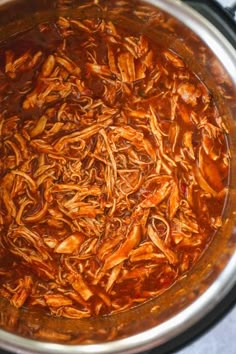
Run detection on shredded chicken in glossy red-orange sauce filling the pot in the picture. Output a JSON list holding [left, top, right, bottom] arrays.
[[0, 13, 229, 318]]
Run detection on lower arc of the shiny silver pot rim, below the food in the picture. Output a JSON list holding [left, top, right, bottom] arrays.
[[0, 253, 236, 354]]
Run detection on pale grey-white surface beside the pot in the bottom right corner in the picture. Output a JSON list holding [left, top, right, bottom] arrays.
[[0, 284, 236, 354]]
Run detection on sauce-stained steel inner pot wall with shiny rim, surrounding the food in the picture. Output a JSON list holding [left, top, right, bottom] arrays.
[[0, 0, 236, 353]]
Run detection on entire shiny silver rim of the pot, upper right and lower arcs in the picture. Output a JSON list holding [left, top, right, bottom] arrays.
[[0, 0, 236, 354]]
